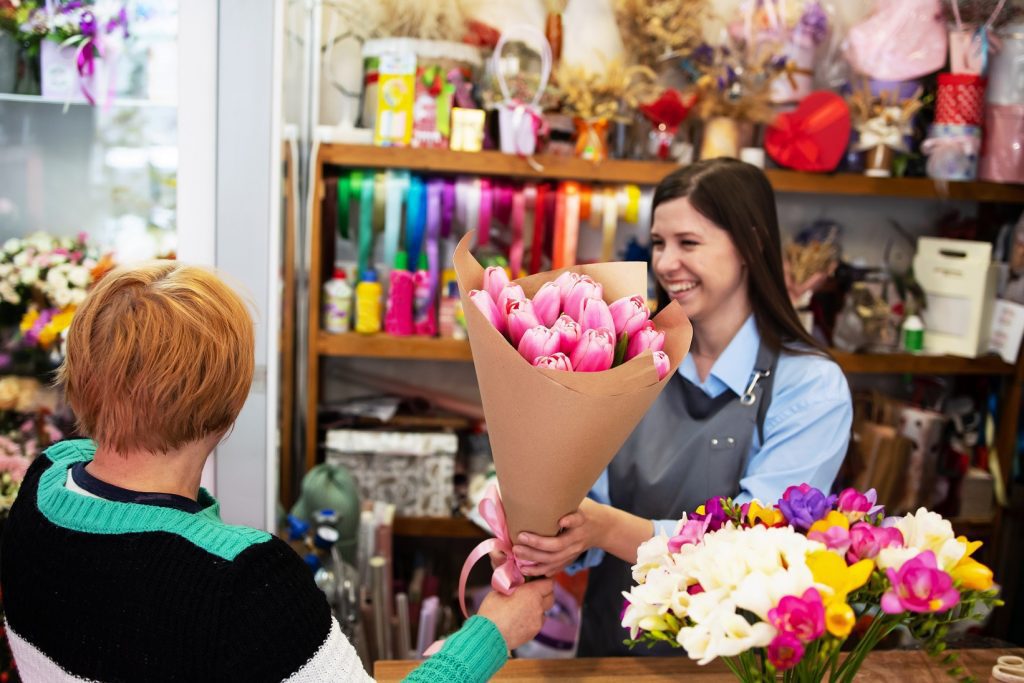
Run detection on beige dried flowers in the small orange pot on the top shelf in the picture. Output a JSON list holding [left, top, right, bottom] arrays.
[[558, 59, 662, 120]]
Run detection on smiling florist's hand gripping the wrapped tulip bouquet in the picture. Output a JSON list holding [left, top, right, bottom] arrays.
[[512, 498, 607, 577]]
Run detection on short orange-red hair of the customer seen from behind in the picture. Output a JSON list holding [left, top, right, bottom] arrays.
[[57, 261, 254, 453]]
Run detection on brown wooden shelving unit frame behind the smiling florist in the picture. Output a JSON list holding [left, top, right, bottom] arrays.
[[299, 144, 1024, 565]]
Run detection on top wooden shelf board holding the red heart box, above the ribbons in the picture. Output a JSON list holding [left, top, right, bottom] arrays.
[[319, 144, 1024, 204]]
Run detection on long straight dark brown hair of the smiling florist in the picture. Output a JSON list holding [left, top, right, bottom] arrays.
[[652, 159, 828, 355]]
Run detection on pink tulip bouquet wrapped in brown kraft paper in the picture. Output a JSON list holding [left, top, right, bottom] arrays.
[[454, 233, 691, 539]]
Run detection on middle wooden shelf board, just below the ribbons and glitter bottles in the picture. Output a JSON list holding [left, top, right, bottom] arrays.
[[316, 332, 1014, 375]]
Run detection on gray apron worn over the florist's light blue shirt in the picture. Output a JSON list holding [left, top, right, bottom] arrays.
[[579, 346, 778, 656]]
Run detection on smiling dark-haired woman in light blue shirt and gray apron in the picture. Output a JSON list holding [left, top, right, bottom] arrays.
[[514, 159, 852, 656]]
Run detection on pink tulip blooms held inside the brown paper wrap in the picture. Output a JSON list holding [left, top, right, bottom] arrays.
[[469, 267, 671, 380]]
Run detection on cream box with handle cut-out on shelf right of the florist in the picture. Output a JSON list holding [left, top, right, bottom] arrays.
[[913, 238, 998, 358]]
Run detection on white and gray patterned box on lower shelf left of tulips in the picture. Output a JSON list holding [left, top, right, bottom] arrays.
[[327, 429, 459, 517]]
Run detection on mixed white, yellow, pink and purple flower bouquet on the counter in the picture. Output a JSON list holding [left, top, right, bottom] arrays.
[[623, 484, 1001, 682]]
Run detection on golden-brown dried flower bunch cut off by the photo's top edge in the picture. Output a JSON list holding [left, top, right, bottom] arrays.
[[614, 0, 709, 65]]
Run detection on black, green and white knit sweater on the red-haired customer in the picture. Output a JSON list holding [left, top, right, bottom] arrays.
[[0, 440, 507, 682]]
